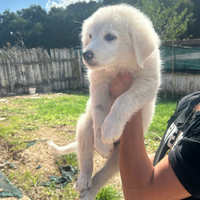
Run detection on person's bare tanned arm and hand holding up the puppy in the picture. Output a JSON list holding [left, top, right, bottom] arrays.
[[111, 75, 191, 200]]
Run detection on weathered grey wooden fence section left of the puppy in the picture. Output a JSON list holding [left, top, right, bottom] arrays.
[[0, 48, 84, 96]]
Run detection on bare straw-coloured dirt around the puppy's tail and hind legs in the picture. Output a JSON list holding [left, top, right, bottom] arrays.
[[0, 125, 122, 200]]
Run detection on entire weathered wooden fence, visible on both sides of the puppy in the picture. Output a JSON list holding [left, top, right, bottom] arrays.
[[0, 48, 200, 96]]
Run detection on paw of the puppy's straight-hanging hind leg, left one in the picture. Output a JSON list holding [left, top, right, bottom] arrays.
[[76, 175, 92, 192]]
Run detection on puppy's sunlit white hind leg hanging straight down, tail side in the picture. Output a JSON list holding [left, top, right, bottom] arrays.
[[76, 112, 94, 192]]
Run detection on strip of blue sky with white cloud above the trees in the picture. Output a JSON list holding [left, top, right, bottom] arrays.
[[0, 0, 89, 13]]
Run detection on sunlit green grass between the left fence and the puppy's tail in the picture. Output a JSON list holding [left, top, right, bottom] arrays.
[[0, 95, 88, 150]]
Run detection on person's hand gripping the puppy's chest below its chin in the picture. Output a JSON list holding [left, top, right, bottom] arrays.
[[110, 73, 133, 99]]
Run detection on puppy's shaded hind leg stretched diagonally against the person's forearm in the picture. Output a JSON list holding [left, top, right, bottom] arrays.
[[80, 144, 119, 200]]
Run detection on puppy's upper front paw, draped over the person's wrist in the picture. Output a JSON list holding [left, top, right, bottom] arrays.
[[101, 120, 123, 144]]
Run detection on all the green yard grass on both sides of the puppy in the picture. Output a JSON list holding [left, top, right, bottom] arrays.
[[0, 94, 177, 200]]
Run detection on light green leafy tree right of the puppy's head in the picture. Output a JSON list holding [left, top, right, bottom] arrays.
[[136, 0, 193, 41]]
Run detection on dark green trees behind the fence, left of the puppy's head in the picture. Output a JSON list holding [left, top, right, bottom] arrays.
[[0, 1, 99, 49]]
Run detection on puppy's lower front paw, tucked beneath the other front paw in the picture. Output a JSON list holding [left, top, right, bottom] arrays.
[[94, 139, 114, 158]]
